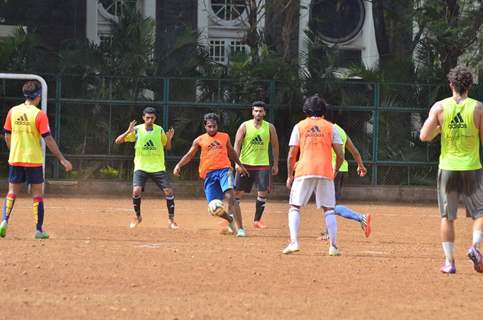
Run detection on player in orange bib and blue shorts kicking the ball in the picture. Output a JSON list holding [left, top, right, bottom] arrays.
[[173, 113, 248, 237]]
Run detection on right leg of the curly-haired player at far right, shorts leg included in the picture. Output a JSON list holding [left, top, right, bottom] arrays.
[[464, 169, 483, 272]]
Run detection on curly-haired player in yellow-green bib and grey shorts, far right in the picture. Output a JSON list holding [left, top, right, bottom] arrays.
[[420, 66, 483, 273]]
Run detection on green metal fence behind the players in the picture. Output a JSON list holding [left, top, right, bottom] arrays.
[[0, 75, 483, 185]]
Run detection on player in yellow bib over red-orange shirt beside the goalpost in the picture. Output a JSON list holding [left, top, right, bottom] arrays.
[[0, 81, 72, 239]]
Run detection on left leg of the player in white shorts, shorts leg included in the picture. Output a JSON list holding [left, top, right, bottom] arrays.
[[282, 178, 316, 254]]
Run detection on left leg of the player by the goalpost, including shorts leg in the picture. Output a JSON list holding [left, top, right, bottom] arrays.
[[0, 166, 26, 238]]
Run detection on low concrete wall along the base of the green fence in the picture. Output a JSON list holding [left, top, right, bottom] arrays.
[[0, 180, 436, 203]]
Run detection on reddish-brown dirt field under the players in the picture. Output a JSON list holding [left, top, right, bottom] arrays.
[[0, 196, 483, 320]]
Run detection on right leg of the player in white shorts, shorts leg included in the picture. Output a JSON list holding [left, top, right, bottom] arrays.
[[315, 178, 340, 256]]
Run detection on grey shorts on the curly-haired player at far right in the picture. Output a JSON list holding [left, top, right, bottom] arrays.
[[438, 169, 483, 221]]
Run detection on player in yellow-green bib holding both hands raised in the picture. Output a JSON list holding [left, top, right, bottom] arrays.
[[115, 107, 178, 229]]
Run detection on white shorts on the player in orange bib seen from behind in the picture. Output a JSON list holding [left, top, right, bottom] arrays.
[[290, 177, 335, 208]]
